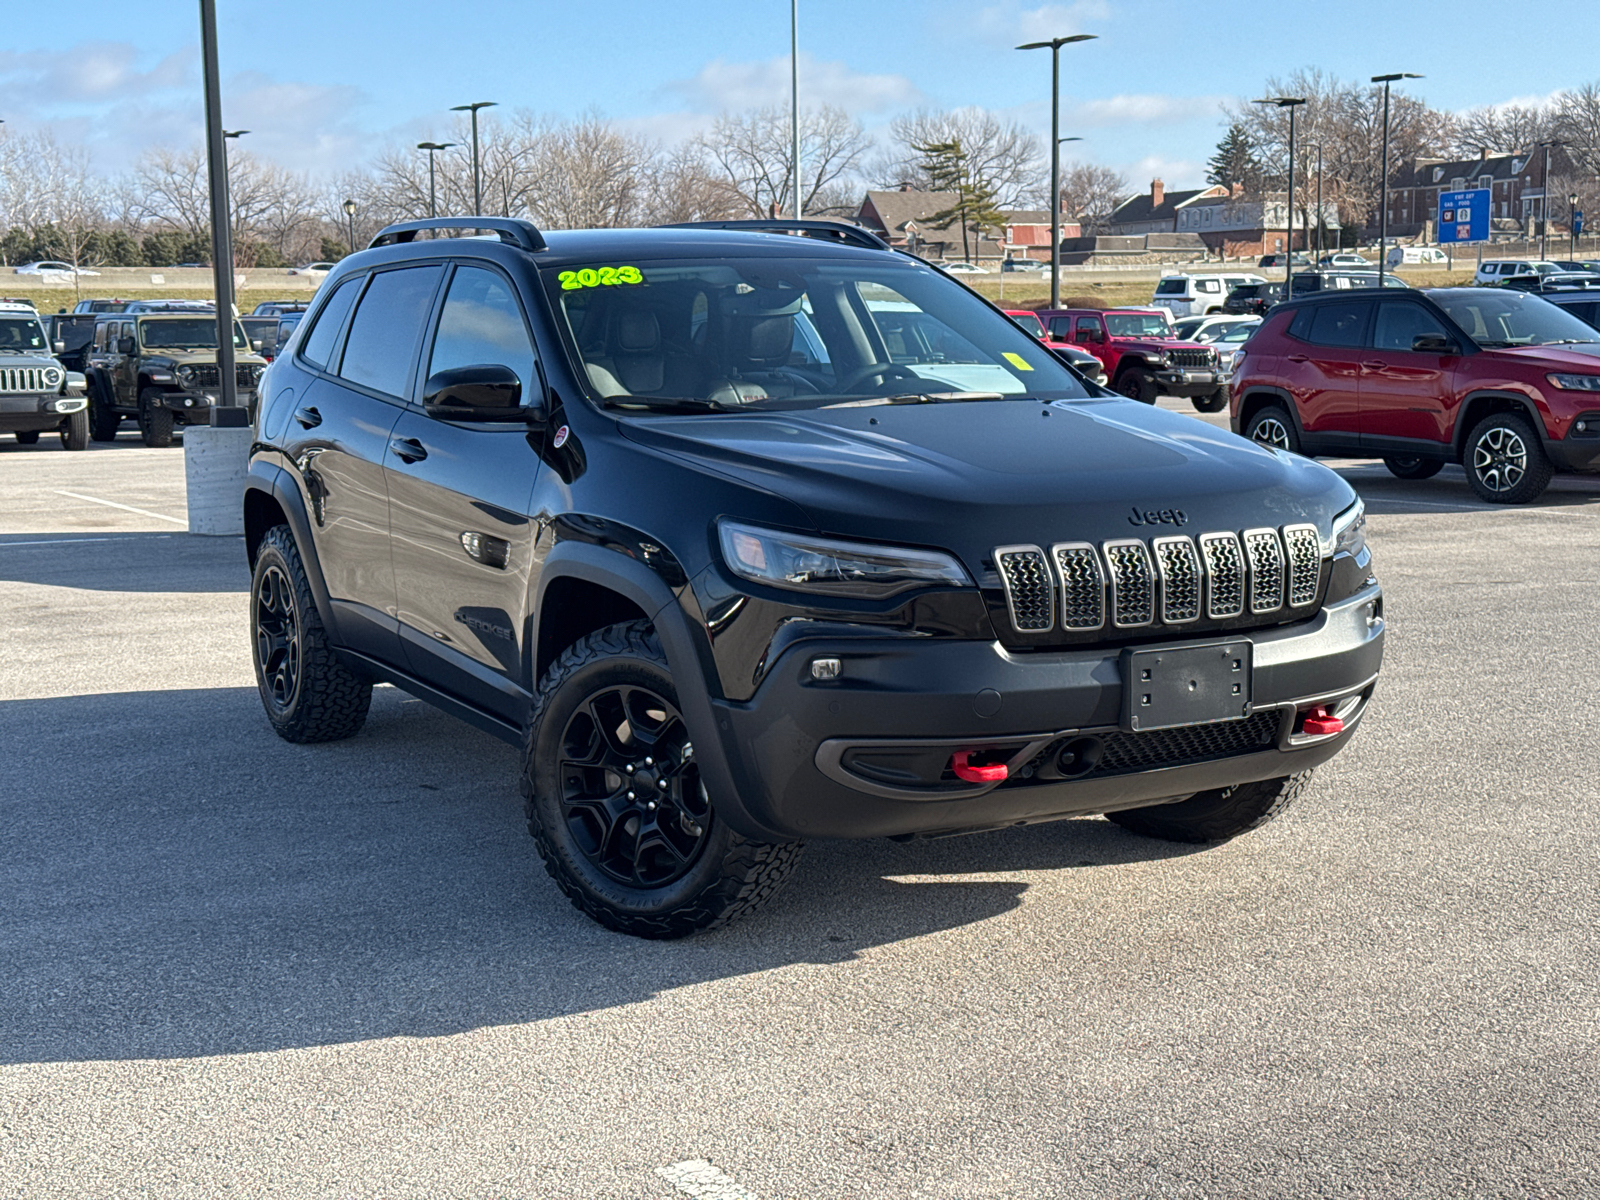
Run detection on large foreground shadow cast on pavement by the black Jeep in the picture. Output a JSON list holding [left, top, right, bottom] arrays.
[[0, 688, 1187, 1064]]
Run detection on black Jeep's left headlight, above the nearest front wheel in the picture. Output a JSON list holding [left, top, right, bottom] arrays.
[[718, 522, 971, 600]]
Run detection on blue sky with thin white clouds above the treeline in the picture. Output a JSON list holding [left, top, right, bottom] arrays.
[[0, 0, 1600, 187]]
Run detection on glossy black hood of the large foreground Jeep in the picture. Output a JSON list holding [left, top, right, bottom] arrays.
[[622, 398, 1355, 571]]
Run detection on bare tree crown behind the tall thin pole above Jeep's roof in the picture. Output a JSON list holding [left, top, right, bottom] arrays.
[[698, 106, 872, 218]]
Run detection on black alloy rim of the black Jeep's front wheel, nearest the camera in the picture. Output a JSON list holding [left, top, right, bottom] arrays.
[[557, 685, 712, 888]]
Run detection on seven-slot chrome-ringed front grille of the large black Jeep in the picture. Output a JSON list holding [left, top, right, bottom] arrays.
[[994, 525, 1322, 635]]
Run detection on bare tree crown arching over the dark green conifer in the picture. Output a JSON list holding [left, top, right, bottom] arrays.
[[870, 109, 1050, 208]]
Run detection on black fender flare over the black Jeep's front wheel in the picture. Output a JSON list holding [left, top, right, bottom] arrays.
[[528, 541, 789, 842]]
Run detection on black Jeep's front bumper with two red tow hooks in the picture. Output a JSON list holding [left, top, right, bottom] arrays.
[[699, 586, 1384, 838]]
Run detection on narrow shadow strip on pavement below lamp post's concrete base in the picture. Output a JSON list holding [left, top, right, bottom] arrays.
[[0, 528, 250, 592]]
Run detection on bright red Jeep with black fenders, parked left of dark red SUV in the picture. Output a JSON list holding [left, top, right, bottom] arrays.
[[1038, 309, 1227, 413]]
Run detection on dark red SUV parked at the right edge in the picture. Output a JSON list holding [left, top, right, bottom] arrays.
[[1232, 288, 1600, 504]]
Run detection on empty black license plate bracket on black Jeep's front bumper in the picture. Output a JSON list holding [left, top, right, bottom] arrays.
[[1122, 638, 1254, 733]]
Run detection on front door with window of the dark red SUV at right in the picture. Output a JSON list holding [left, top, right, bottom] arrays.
[[1360, 301, 1459, 448]]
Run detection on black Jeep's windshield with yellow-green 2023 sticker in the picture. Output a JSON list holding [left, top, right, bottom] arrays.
[[546, 254, 1086, 411]]
